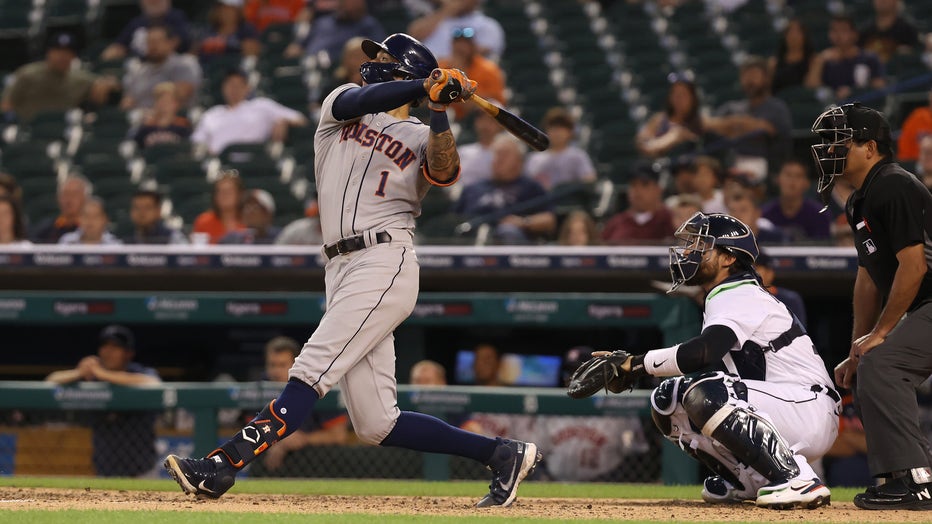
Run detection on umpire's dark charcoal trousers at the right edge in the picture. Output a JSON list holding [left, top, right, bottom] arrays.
[[857, 302, 932, 477]]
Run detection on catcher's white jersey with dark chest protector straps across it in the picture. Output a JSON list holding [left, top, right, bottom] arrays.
[[702, 278, 832, 386]]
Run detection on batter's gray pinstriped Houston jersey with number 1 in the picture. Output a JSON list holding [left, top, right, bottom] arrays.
[[314, 84, 430, 244]]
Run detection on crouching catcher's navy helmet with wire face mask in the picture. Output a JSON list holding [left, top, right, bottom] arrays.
[[670, 211, 760, 292]]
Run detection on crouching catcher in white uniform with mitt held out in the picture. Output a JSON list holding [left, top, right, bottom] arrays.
[[568, 213, 840, 509]]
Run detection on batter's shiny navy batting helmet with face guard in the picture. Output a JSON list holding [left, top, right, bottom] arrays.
[[359, 33, 438, 84]]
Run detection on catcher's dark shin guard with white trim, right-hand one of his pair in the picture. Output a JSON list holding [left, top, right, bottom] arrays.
[[683, 380, 799, 482]]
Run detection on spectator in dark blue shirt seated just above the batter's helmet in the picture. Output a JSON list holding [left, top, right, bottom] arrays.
[[285, 0, 386, 61]]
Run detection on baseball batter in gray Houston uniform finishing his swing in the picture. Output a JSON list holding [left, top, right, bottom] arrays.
[[165, 33, 541, 507]]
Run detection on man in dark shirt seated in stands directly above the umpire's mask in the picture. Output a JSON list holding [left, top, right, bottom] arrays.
[[806, 15, 886, 101]]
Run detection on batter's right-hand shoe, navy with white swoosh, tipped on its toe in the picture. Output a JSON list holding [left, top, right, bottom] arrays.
[[476, 439, 543, 508]]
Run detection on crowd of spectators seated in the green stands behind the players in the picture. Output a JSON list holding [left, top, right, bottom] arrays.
[[0, 0, 932, 245]]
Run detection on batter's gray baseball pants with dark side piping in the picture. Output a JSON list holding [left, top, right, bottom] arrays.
[[289, 229, 420, 444]]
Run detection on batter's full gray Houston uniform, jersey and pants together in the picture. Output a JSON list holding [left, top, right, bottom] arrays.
[[289, 84, 438, 444]]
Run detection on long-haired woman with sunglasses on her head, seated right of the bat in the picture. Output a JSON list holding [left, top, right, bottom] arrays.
[[635, 75, 703, 158]]
